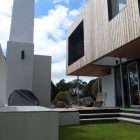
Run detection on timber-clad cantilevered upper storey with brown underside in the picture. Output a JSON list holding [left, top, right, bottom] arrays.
[[67, 0, 140, 76]]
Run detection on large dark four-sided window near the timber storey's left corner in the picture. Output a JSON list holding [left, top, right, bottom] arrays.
[[68, 21, 84, 65]]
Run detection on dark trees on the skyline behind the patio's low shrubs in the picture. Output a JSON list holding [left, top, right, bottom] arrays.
[[51, 79, 101, 101]]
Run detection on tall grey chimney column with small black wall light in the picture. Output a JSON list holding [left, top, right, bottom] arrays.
[[6, 0, 35, 100]]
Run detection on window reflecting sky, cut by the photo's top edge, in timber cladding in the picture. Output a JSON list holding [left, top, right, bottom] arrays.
[[108, 0, 127, 20]]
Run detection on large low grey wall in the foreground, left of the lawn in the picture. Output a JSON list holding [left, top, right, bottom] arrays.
[[0, 106, 58, 140]]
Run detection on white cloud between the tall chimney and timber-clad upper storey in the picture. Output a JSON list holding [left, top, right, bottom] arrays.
[[34, 5, 79, 83]]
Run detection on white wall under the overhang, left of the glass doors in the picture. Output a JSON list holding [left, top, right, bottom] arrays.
[[101, 68, 116, 107]]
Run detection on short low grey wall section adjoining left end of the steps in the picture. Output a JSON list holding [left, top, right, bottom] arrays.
[[59, 111, 79, 126]]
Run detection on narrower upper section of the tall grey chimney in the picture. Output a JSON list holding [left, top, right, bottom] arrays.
[[9, 0, 35, 43]]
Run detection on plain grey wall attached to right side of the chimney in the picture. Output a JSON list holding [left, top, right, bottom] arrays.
[[33, 55, 51, 107]]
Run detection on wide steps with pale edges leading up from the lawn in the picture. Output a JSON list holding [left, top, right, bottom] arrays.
[[79, 108, 140, 124]]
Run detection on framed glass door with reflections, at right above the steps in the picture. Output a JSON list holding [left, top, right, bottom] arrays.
[[128, 62, 140, 107]]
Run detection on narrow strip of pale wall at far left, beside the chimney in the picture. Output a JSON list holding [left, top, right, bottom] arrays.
[[0, 46, 7, 106]]
